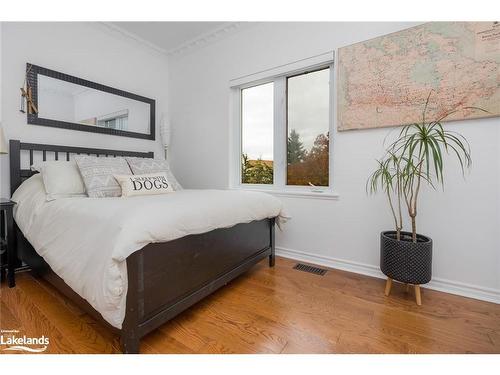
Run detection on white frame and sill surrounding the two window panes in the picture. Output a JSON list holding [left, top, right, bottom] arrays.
[[229, 52, 338, 203]]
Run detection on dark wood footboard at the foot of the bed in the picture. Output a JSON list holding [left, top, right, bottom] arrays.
[[121, 219, 274, 353]]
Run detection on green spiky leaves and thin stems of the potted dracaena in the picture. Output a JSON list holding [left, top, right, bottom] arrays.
[[367, 91, 487, 242]]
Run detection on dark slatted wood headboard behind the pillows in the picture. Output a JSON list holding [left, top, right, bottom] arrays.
[[9, 139, 154, 195]]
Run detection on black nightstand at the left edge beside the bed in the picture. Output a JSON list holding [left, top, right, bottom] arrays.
[[0, 198, 19, 288]]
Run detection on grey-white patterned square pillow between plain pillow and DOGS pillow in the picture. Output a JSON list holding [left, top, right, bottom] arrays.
[[75, 156, 130, 198]]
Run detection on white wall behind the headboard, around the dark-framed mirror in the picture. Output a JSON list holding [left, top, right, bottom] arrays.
[[0, 22, 168, 197]]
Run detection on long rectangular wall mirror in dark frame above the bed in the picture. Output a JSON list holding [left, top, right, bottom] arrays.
[[26, 63, 155, 140]]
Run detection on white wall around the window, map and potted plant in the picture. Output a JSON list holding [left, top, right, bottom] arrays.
[[169, 23, 500, 302]]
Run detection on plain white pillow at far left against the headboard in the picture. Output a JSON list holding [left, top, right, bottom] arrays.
[[31, 160, 87, 201]]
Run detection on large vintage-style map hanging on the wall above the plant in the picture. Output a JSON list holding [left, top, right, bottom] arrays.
[[337, 22, 500, 130]]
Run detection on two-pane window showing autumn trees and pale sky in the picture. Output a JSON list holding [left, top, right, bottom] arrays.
[[233, 65, 332, 192]]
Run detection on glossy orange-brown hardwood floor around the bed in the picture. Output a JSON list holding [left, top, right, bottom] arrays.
[[0, 258, 500, 353]]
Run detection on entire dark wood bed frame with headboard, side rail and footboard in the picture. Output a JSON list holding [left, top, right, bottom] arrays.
[[10, 140, 275, 353]]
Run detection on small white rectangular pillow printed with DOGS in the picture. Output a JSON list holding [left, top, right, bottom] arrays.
[[115, 172, 174, 197]]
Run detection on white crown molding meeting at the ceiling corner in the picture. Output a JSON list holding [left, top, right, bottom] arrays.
[[93, 22, 255, 57]]
